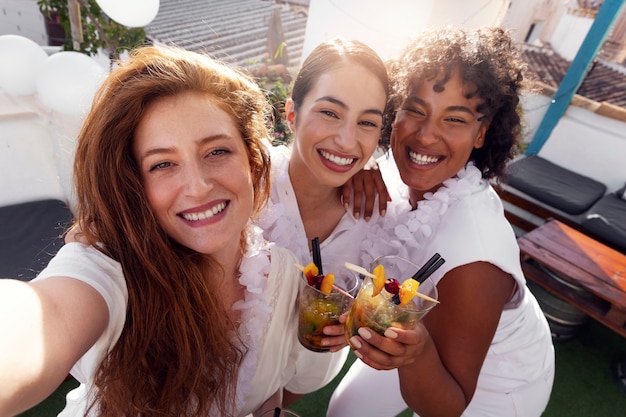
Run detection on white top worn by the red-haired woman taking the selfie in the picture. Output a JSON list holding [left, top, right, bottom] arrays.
[[35, 228, 335, 416]]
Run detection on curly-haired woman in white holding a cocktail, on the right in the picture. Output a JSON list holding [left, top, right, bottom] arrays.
[[328, 28, 554, 417]]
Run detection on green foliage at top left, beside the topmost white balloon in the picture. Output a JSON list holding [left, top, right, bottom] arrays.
[[37, 0, 146, 59]]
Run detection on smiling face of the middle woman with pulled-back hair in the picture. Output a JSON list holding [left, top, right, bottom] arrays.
[[286, 61, 387, 187]]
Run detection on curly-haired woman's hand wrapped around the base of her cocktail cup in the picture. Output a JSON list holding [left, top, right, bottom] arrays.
[[350, 323, 430, 370]]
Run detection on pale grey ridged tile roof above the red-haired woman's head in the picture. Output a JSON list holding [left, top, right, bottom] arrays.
[[145, 0, 307, 66]]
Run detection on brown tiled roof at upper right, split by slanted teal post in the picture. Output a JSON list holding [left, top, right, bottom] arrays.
[[524, 46, 626, 108]]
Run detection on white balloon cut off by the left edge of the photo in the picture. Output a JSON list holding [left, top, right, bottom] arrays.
[[0, 35, 48, 96]]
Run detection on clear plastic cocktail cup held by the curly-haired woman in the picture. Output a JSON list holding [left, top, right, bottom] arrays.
[[346, 255, 437, 348]]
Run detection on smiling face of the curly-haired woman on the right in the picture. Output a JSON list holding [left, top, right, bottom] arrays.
[[391, 72, 489, 208]]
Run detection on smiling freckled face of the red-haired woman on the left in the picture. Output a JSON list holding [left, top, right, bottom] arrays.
[[133, 92, 254, 261]]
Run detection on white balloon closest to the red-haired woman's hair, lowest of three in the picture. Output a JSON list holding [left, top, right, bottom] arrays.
[[37, 51, 106, 116]]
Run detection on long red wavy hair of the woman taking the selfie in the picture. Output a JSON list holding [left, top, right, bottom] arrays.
[[74, 47, 269, 417]]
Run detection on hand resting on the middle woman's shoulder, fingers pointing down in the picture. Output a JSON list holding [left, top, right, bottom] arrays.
[[341, 165, 391, 221]]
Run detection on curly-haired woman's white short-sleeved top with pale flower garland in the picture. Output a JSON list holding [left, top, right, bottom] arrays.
[[363, 153, 554, 392]]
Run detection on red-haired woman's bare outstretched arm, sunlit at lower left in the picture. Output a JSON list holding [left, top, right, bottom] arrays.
[[0, 277, 109, 416]]
